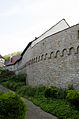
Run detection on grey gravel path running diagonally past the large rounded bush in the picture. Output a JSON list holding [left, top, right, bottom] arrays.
[[0, 85, 57, 119]]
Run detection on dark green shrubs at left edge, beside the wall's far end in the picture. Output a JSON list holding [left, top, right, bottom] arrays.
[[0, 69, 26, 91]]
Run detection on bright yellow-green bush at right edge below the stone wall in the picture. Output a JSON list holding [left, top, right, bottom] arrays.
[[66, 90, 79, 107]]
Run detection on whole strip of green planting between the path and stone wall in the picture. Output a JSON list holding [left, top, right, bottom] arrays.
[[0, 68, 79, 119]]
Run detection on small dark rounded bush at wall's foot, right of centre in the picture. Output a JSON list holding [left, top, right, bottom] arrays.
[[44, 87, 57, 98]]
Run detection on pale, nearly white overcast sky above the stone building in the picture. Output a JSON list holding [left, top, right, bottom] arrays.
[[0, 0, 79, 56]]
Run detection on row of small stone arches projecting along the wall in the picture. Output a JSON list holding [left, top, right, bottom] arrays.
[[23, 46, 79, 67]]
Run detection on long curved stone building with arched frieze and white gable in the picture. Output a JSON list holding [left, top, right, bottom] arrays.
[[5, 19, 79, 90]]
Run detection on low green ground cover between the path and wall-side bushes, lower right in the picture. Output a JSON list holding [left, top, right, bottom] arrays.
[[33, 97, 79, 119]]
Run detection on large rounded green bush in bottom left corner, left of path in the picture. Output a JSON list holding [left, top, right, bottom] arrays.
[[0, 92, 26, 119]]
